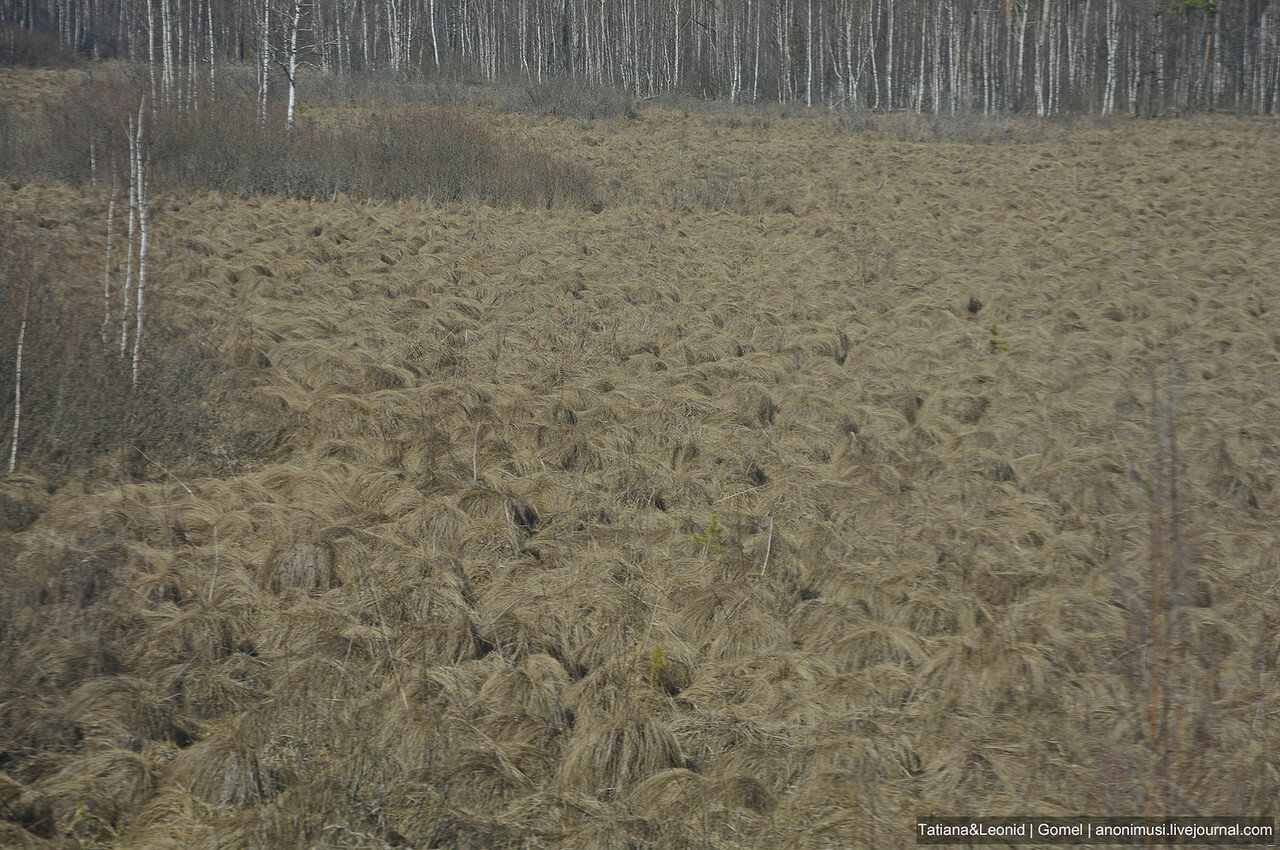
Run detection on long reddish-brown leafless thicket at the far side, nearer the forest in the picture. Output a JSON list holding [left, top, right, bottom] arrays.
[[0, 81, 593, 207]]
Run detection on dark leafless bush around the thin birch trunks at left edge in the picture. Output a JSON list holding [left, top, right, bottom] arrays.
[[0, 221, 230, 484]]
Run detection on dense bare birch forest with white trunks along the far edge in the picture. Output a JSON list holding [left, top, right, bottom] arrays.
[[3, 0, 1280, 118]]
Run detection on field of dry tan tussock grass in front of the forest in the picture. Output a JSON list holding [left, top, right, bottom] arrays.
[[0, 74, 1280, 849]]
